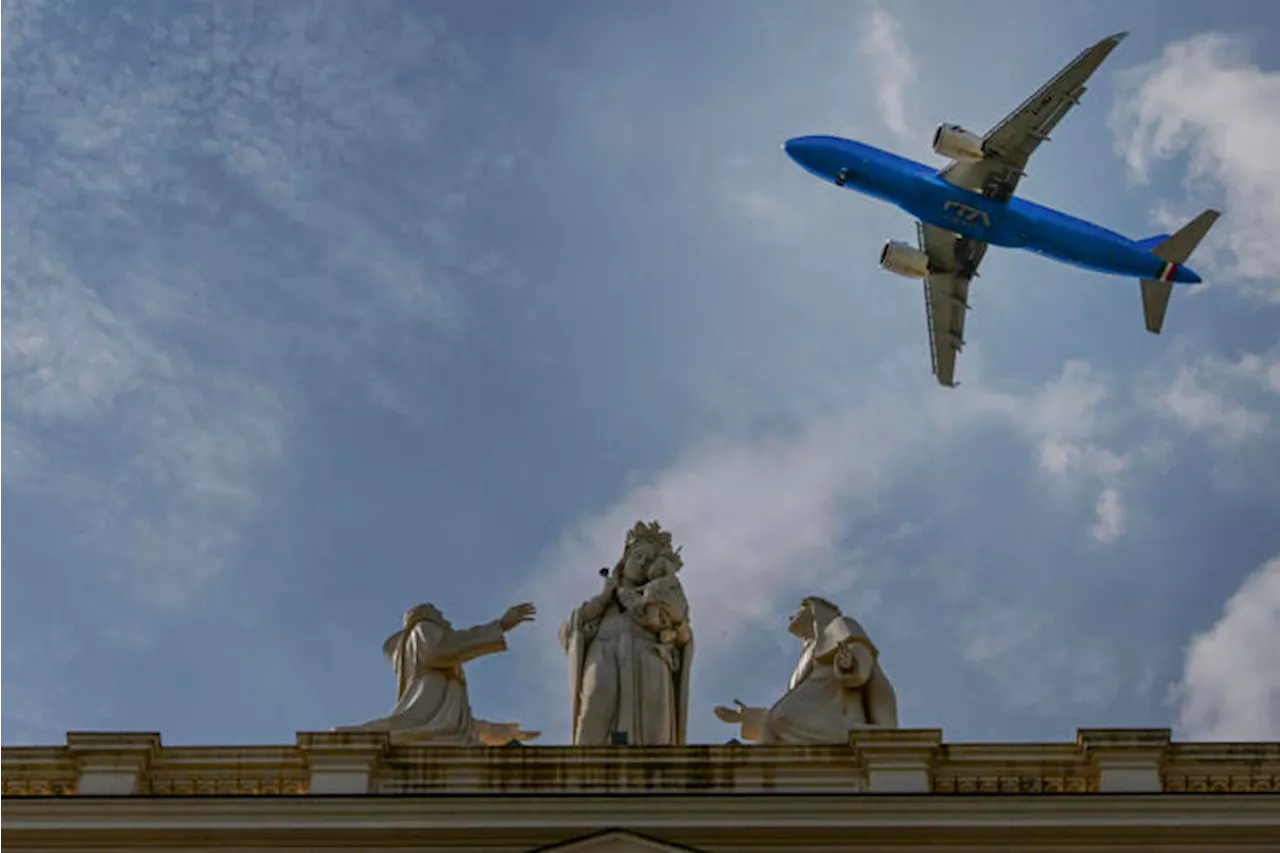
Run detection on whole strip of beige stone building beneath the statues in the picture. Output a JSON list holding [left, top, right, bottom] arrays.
[[0, 730, 1280, 853]]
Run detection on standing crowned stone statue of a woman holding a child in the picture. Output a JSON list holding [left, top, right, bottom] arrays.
[[561, 521, 694, 747]]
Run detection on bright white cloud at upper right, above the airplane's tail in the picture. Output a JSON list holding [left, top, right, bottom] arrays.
[[1112, 33, 1280, 302]]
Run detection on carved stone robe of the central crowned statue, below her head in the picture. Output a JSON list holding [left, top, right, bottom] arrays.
[[561, 580, 694, 747]]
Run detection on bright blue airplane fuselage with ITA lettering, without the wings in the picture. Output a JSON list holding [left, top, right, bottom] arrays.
[[786, 136, 1201, 284]]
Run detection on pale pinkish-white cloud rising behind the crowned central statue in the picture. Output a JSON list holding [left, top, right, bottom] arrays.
[[527, 397, 923, 643]]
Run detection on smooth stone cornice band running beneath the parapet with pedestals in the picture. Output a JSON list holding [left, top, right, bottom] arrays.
[[0, 792, 1280, 850]]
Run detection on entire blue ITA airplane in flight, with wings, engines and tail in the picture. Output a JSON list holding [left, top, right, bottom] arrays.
[[783, 32, 1219, 388]]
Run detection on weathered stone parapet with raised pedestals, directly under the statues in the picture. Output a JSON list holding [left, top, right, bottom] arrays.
[[0, 729, 1280, 798]]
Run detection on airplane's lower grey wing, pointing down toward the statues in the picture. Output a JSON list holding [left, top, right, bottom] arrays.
[[916, 222, 987, 388]]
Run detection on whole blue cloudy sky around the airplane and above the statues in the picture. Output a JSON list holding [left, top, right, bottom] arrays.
[[0, 0, 1280, 744]]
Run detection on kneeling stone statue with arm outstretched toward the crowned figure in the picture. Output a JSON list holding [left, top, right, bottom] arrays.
[[335, 596, 540, 747]]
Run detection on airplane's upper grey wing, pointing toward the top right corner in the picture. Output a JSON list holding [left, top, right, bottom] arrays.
[[940, 32, 1129, 201]]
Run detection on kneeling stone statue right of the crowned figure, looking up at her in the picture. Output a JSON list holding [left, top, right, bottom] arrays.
[[716, 596, 897, 744]]
